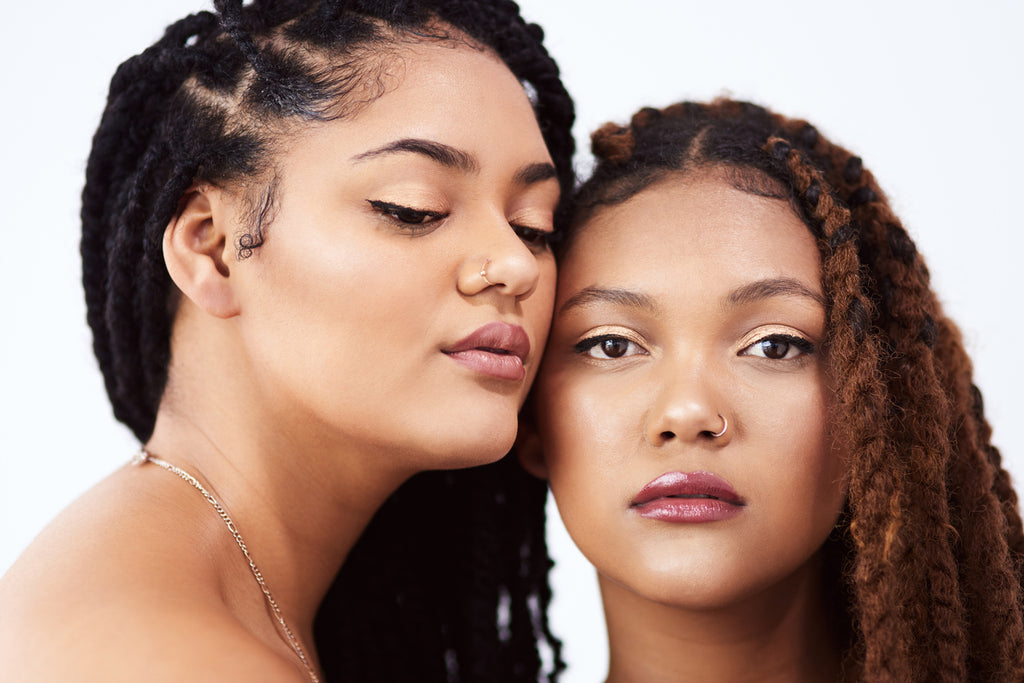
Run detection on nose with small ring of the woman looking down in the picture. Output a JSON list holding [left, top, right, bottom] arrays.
[[459, 210, 547, 299]]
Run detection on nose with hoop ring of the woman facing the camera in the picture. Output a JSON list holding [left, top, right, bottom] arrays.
[[644, 358, 735, 446]]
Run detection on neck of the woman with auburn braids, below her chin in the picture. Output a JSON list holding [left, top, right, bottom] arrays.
[[599, 561, 844, 683]]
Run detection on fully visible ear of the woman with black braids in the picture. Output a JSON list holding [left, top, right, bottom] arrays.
[[163, 185, 239, 318]]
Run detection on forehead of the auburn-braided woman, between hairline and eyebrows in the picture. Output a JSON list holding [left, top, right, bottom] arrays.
[[559, 174, 820, 301]]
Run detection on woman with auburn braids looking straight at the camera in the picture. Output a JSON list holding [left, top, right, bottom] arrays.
[[520, 99, 1024, 683]]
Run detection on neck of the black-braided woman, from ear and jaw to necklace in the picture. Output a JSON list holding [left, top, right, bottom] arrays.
[[146, 307, 415, 648]]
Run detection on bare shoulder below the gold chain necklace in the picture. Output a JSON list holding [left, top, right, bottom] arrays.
[[0, 466, 306, 683]]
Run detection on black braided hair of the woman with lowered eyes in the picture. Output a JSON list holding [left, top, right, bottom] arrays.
[[81, 0, 573, 681]]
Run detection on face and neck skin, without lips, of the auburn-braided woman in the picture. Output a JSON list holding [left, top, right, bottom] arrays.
[[525, 170, 845, 683]]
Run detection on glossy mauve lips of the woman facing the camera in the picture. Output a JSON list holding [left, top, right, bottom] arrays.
[[630, 472, 746, 523]]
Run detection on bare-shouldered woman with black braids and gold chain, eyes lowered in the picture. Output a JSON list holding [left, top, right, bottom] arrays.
[[0, 0, 572, 681]]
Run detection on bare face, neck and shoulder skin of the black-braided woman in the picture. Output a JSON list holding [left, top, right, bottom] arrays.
[[0, 44, 559, 682]]
